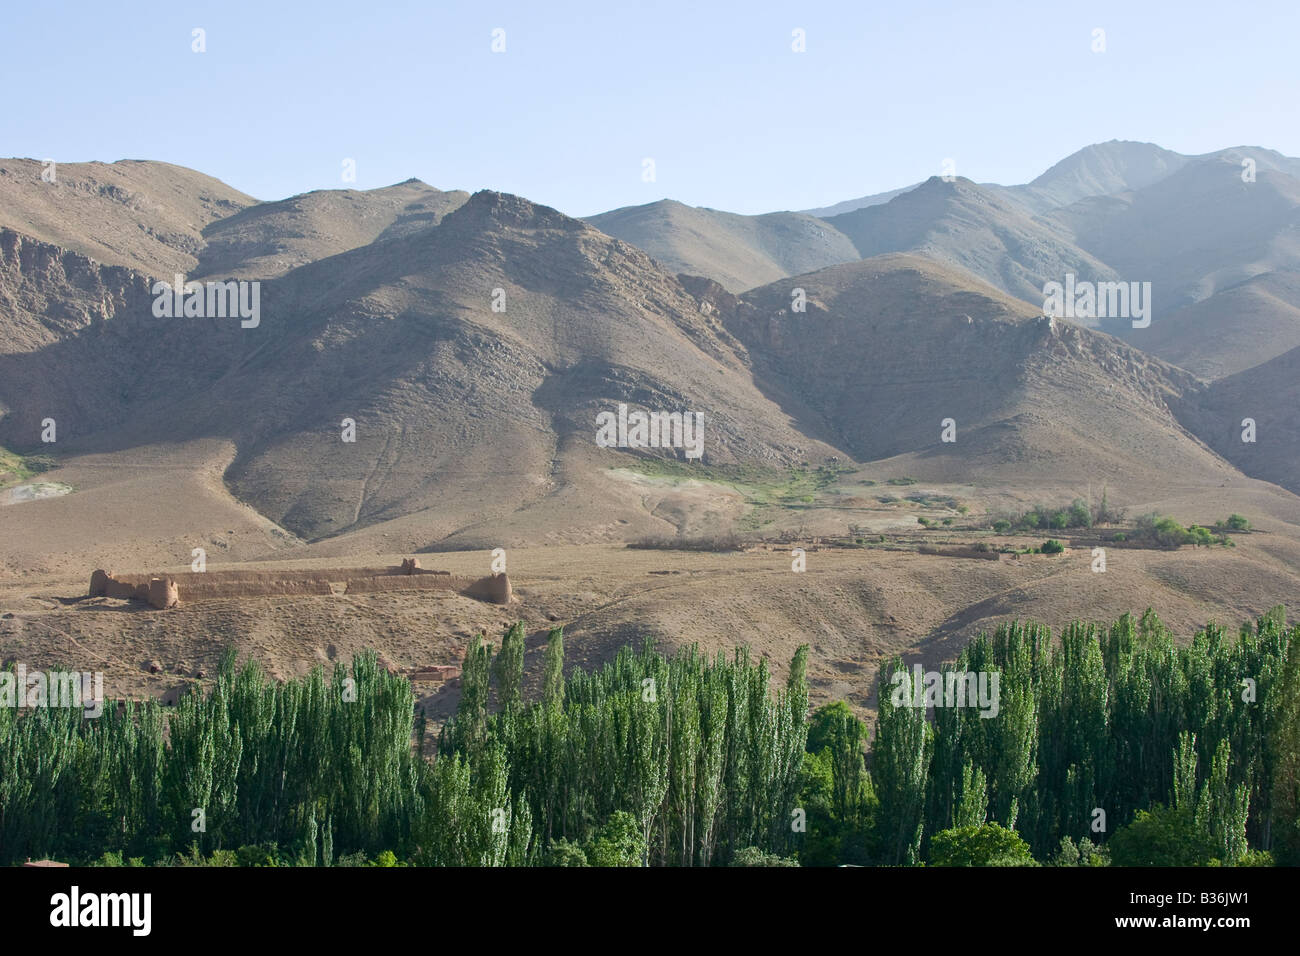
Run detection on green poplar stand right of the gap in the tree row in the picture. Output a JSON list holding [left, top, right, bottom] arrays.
[[810, 607, 1300, 865]]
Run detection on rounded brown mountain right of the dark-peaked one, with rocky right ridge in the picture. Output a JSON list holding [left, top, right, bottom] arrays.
[[728, 255, 1230, 494]]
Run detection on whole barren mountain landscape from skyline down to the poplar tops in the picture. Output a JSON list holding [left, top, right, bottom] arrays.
[[0, 143, 1300, 704]]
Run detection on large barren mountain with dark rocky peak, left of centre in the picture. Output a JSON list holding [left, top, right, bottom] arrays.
[[0, 193, 833, 542]]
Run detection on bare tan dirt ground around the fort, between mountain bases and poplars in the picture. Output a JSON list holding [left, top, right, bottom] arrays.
[[0, 460, 1300, 718]]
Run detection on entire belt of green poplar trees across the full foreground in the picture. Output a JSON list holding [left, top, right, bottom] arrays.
[[0, 609, 1300, 866]]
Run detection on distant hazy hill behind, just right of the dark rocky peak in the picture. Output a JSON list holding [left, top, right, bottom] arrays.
[[588, 199, 858, 293]]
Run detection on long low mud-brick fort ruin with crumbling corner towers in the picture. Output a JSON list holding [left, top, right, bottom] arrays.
[[90, 558, 511, 610]]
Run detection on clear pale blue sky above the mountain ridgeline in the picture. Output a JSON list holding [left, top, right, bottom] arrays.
[[0, 0, 1300, 215]]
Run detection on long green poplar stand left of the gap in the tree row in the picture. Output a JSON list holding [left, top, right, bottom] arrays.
[[0, 624, 809, 866]]
